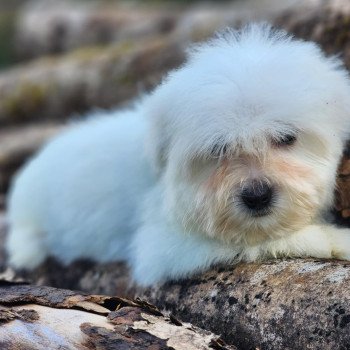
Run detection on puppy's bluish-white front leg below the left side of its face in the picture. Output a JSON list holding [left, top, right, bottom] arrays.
[[129, 222, 238, 285]]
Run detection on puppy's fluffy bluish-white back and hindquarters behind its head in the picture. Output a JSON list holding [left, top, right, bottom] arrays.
[[7, 111, 152, 267]]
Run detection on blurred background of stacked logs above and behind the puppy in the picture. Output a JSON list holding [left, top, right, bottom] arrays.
[[0, 0, 350, 209]]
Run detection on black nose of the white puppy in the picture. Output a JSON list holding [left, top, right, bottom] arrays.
[[241, 181, 272, 211]]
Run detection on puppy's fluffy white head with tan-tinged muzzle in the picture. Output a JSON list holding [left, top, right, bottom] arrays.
[[146, 25, 350, 244]]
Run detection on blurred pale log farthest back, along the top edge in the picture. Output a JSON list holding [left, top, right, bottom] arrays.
[[13, 0, 292, 60]]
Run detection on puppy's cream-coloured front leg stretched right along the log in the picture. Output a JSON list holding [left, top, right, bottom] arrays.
[[243, 225, 350, 261]]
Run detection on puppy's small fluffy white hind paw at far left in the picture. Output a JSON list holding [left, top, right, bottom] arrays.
[[6, 226, 47, 269]]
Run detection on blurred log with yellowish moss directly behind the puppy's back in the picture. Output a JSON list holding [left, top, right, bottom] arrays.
[[0, 38, 184, 126]]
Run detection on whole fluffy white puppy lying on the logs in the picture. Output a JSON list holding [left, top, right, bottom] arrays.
[[7, 25, 350, 285]]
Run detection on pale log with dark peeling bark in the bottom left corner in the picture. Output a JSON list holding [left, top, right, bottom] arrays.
[[0, 281, 236, 350]]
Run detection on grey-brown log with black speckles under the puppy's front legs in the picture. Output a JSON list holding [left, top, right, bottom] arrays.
[[142, 259, 350, 350]]
